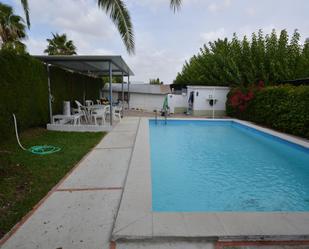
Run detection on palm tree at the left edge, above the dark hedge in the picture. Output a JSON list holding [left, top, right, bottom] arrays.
[[0, 3, 26, 52]]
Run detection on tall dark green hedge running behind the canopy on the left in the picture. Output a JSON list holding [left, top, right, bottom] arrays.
[[0, 51, 103, 143]]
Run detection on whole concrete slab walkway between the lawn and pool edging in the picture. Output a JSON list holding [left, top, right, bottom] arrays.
[[1, 117, 139, 249]]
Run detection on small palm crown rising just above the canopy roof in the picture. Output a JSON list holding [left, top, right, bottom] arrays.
[[44, 33, 76, 55]]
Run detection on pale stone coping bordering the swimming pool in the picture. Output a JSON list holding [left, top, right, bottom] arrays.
[[112, 118, 309, 241]]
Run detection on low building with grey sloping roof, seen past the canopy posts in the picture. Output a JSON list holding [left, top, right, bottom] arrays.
[[103, 83, 171, 112]]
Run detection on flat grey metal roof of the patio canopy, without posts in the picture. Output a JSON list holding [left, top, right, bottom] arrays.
[[33, 55, 134, 77]]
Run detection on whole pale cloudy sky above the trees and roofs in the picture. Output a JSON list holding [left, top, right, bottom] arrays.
[[1, 0, 309, 84]]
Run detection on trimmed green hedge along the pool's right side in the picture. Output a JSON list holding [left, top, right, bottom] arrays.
[[227, 85, 309, 138]]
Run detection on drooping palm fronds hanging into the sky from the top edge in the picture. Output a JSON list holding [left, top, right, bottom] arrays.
[[20, 0, 182, 54]]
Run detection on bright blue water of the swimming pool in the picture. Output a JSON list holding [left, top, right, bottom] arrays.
[[149, 120, 309, 212]]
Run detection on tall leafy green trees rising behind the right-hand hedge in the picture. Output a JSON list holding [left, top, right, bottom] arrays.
[[174, 30, 309, 86]]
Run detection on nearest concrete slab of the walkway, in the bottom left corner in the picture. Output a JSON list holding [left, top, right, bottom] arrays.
[[1, 191, 121, 249]]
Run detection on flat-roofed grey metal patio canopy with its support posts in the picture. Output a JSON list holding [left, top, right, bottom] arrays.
[[34, 55, 134, 125]]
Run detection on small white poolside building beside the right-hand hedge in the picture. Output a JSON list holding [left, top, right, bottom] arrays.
[[168, 86, 230, 117]]
